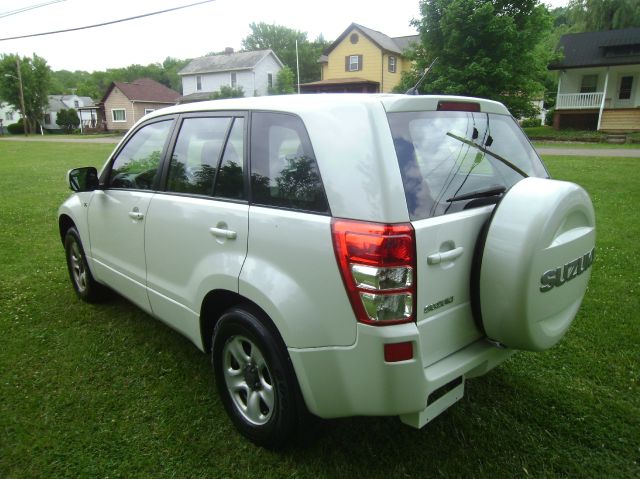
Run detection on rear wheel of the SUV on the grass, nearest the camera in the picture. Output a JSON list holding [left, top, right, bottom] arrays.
[[211, 308, 306, 449]]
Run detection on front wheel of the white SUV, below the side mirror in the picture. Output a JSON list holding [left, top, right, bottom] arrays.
[[64, 226, 108, 303]]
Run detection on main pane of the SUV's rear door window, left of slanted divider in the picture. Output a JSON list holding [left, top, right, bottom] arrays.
[[167, 118, 231, 195]]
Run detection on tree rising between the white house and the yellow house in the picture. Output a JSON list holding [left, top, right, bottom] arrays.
[[242, 22, 329, 83]]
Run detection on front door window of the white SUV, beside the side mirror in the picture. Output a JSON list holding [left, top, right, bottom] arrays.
[[107, 120, 173, 190]]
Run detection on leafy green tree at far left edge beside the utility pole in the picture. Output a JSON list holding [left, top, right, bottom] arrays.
[[0, 54, 51, 133]]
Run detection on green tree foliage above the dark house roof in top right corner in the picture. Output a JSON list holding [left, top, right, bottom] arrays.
[[567, 0, 640, 32]]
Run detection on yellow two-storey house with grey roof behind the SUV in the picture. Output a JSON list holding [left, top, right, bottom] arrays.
[[300, 23, 420, 93]]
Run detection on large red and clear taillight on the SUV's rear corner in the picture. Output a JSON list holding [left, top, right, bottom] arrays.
[[331, 218, 416, 326]]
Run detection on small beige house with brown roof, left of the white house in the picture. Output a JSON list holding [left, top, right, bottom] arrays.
[[102, 78, 180, 131]]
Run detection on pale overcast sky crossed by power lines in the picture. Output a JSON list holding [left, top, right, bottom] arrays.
[[0, 0, 568, 71]]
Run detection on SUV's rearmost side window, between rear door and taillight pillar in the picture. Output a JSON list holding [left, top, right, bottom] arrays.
[[251, 113, 329, 213]]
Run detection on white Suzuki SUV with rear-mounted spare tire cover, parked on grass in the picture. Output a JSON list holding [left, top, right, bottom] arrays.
[[59, 94, 595, 447]]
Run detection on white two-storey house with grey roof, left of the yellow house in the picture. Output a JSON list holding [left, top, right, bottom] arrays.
[[178, 48, 284, 103]]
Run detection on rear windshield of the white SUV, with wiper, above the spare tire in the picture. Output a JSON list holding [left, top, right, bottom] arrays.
[[388, 111, 548, 220]]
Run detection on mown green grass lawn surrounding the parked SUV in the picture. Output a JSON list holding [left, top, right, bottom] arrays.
[[0, 142, 640, 479]]
